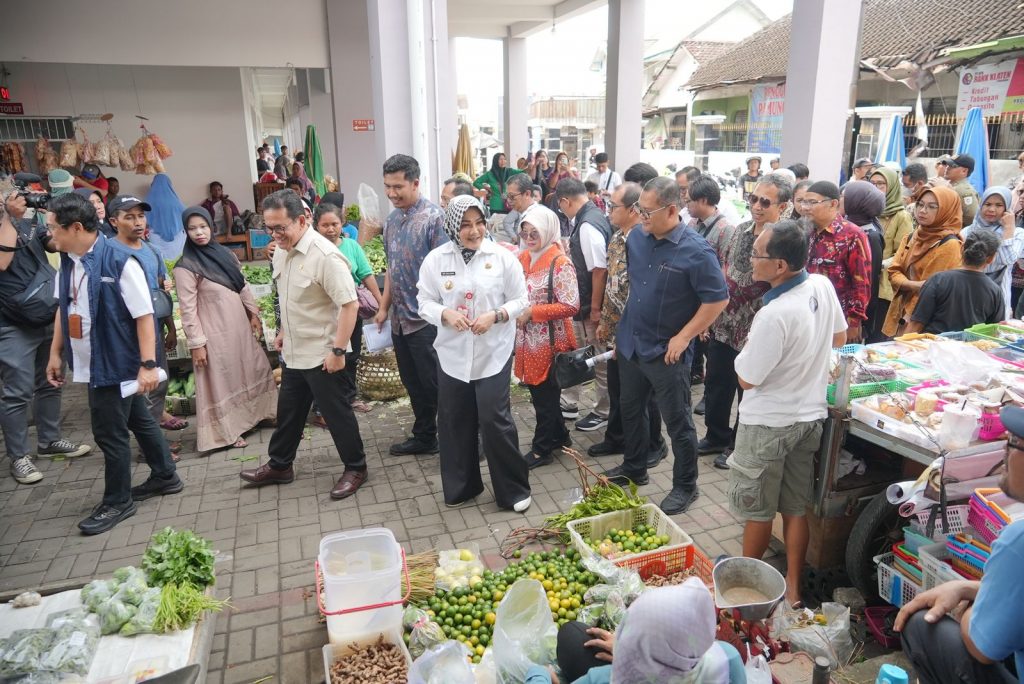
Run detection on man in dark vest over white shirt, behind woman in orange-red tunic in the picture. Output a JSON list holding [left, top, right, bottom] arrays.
[[555, 178, 611, 432]]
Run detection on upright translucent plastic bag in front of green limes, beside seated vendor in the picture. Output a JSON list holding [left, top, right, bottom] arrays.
[[494, 580, 558, 684]]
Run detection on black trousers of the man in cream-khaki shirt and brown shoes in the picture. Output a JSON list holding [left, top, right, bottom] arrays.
[[267, 368, 367, 470]]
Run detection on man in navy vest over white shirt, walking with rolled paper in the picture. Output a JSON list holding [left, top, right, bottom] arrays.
[[46, 195, 184, 535]]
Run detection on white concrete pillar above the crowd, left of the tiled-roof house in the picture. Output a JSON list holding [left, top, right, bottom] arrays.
[[604, 0, 644, 173]]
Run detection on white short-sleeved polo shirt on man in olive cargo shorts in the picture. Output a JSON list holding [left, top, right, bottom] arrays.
[[735, 271, 847, 427]]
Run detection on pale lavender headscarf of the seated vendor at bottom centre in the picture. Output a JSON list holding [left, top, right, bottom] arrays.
[[611, 578, 729, 684]]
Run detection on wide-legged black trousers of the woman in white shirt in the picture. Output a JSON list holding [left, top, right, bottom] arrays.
[[437, 356, 532, 508]]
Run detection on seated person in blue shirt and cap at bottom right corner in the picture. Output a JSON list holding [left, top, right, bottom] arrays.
[[895, 407, 1024, 684]]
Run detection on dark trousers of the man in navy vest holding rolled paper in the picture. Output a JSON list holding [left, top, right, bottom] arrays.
[[89, 385, 176, 508]]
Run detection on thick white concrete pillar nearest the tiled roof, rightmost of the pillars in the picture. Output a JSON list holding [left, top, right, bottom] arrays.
[[782, 0, 862, 180]]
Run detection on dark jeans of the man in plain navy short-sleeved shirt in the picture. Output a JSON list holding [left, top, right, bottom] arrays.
[[618, 356, 697, 488]]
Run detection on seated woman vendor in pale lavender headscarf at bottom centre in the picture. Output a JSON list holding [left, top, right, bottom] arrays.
[[526, 578, 746, 684]]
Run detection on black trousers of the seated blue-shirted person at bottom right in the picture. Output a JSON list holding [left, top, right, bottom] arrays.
[[902, 610, 1017, 684]]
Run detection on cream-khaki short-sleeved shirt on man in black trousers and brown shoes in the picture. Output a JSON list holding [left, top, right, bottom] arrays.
[[273, 227, 355, 370]]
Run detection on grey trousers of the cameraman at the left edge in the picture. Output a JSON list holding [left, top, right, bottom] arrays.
[[0, 322, 60, 460]]
